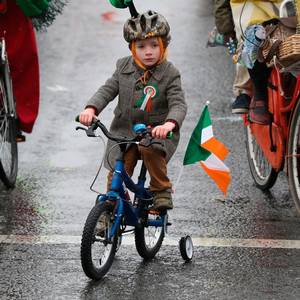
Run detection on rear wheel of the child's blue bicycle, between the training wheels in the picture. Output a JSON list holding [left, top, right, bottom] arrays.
[[134, 214, 165, 259]]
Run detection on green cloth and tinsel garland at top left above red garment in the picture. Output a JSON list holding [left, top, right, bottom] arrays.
[[16, 0, 68, 31]]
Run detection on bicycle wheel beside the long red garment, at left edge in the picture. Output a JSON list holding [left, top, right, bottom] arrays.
[[0, 77, 18, 188]]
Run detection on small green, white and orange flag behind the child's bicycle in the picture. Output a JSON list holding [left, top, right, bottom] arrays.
[[183, 105, 230, 195]]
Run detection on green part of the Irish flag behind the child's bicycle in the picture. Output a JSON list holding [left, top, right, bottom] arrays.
[[183, 105, 211, 166]]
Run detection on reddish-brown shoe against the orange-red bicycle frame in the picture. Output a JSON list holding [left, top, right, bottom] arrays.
[[249, 100, 272, 125]]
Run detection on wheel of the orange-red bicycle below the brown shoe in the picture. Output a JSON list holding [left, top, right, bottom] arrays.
[[245, 126, 278, 191]]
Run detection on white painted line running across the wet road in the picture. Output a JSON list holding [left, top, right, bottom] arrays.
[[0, 235, 300, 249]]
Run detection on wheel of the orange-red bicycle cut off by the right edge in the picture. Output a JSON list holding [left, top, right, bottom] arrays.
[[287, 99, 300, 214]]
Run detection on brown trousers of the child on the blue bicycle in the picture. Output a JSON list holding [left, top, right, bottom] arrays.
[[107, 145, 172, 192]]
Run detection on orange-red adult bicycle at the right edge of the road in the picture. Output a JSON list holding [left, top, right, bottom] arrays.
[[244, 58, 300, 214]]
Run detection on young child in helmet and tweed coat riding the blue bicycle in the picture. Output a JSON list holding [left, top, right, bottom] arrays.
[[80, 11, 187, 211]]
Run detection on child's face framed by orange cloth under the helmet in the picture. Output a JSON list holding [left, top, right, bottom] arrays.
[[136, 37, 160, 67]]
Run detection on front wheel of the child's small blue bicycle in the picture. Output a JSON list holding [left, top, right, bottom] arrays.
[[81, 203, 118, 280]]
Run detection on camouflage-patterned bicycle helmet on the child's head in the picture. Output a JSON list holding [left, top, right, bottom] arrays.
[[123, 10, 171, 46]]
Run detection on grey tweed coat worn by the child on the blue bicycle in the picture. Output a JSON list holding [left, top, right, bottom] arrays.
[[87, 56, 187, 169]]
